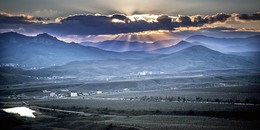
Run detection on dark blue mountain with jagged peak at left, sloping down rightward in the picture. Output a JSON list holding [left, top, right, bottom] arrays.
[[0, 32, 148, 67]]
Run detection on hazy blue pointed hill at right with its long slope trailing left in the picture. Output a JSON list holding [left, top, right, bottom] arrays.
[[23, 45, 258, 79]]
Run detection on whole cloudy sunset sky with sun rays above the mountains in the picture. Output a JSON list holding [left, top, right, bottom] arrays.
[[0, 0, 260, 42]]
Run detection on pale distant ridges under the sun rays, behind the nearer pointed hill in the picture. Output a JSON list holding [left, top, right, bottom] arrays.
[[80, 35, 260, 54]]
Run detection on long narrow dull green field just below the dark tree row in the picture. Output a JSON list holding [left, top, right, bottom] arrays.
[[29, 99, 260, 111]]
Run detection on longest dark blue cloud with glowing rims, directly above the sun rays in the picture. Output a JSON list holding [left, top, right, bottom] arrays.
[[46, 13, 230, 35]]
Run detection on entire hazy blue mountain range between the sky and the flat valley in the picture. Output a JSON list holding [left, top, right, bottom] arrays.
[[0, 32, 260, 82]]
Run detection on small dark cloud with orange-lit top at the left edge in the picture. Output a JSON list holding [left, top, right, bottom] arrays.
[[0, 13, 48, 24]]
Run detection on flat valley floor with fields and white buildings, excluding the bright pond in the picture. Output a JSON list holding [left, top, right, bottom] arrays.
[[0, 75, 260, 130]]
